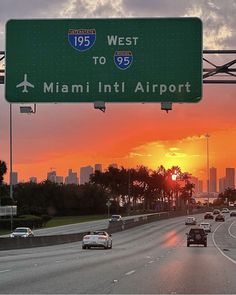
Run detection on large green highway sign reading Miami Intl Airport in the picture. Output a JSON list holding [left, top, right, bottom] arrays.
[[5, 18, 202, 103]]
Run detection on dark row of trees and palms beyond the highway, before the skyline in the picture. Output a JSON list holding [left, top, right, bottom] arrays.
[[0, 161, 194, 216]]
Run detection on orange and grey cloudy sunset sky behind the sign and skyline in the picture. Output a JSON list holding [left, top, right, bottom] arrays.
[[0, 0, 236, 191]]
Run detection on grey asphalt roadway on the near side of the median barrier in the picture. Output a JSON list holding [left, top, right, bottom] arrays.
[[0, 214, 236, 294]]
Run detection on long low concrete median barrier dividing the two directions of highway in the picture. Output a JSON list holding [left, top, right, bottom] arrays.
[[0, 210, 206, 250]]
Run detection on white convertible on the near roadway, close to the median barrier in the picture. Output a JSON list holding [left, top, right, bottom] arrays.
[[82, 231, 112, 249]]
